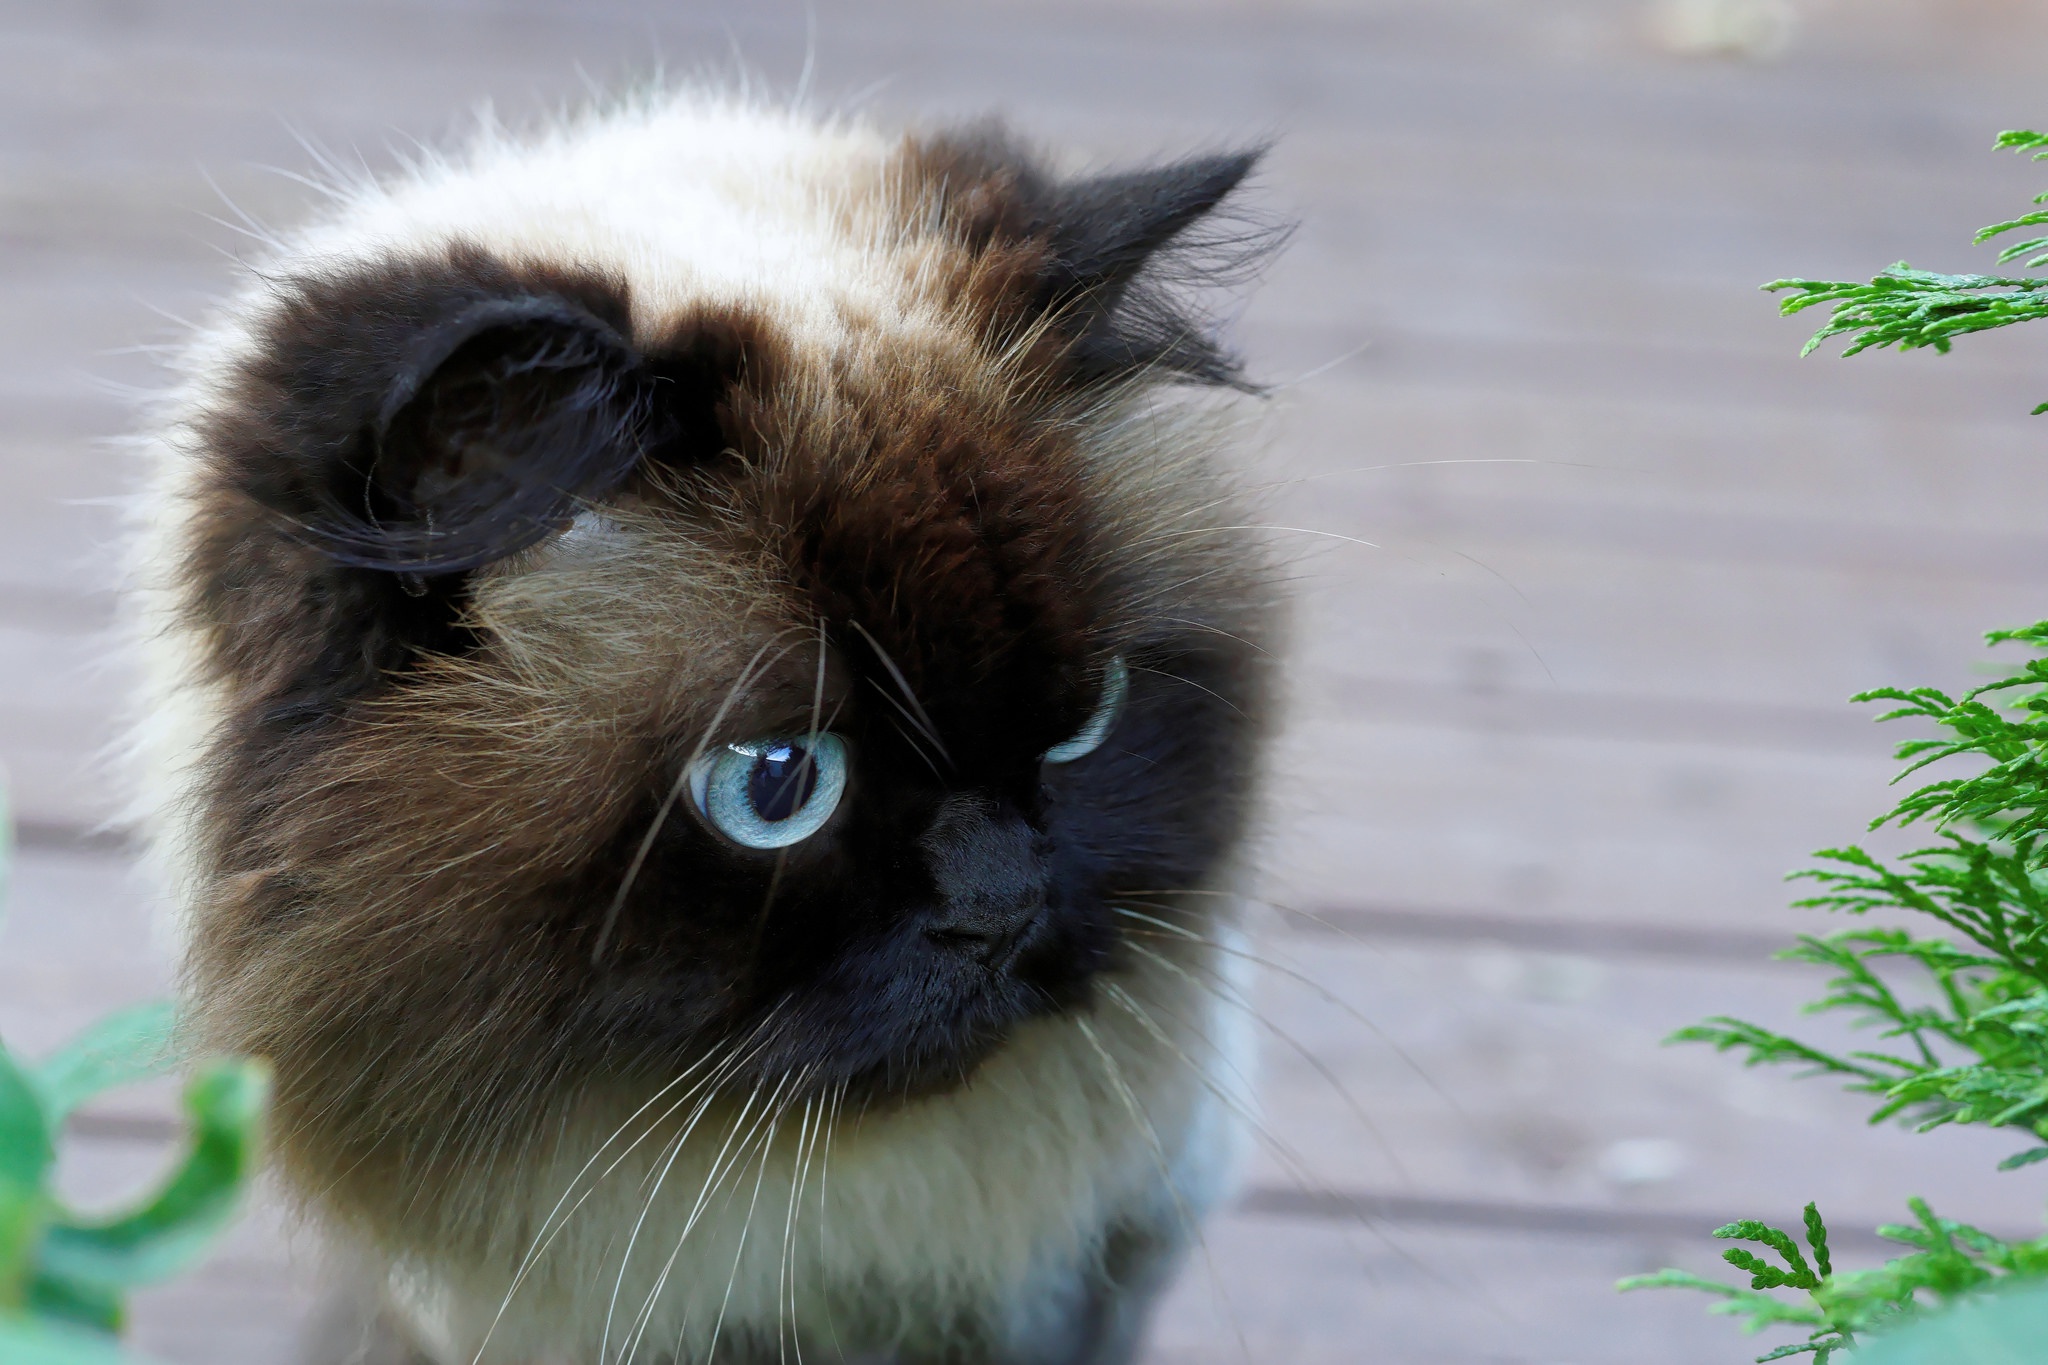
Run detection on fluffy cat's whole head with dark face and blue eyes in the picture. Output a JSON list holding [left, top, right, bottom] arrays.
[[160, 117, 1272, 1203]]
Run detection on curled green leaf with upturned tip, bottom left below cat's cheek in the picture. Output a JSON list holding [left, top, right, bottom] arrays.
[[41, 1062, 268, 1287]]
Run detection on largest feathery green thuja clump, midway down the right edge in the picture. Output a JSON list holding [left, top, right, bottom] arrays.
[[1673, 622, 2048, 1169]]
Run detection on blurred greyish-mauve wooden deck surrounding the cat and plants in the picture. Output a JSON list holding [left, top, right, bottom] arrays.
[[0, 0, 2048, 1365]]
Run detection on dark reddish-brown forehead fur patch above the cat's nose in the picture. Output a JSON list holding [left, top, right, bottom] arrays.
[[733, 339, 1100, 720]]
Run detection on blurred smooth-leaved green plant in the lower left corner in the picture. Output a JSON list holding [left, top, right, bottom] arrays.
[[0, 789, 268, 1365]]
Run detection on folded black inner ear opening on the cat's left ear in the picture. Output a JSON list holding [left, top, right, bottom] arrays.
[[305, 291, 649, 575]]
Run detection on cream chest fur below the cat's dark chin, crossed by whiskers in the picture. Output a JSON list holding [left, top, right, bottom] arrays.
[[395, 929, 1251, 1365]]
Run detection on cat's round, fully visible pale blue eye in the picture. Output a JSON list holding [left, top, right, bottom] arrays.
[[690, 735, 846, 849]]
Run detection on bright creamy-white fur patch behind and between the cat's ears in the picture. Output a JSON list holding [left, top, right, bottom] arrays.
[[272, 100, 936, 358]]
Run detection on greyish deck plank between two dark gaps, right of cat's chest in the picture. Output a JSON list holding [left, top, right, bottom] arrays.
[[1212, 933, 2042, 1236]]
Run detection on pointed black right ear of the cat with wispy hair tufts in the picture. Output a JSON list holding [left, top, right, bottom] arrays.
[[1044, 149, 1276, 385]]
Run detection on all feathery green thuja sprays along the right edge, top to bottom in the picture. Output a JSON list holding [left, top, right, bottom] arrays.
[[1620, 133, 2048, 1365]]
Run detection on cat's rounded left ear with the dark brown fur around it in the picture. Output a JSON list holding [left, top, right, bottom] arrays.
[[188, 257, 668, 726]]
